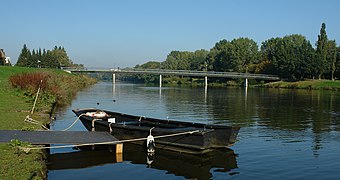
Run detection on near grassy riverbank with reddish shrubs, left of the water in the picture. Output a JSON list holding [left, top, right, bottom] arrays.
[[0, 66, 95, 179]]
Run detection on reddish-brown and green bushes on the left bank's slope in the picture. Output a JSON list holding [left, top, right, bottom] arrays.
[[9, 72, 96, 110]]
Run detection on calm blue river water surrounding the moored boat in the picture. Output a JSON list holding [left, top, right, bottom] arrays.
[[48, 82, 340, 179]]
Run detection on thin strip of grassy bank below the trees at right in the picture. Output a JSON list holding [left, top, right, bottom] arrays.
[[261, 80, 340, 90]]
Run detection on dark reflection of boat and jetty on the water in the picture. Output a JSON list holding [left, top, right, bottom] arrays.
[[48, 143, 237, 179]]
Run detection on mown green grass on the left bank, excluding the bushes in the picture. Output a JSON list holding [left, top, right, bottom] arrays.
[[0, 67, 46, 179]]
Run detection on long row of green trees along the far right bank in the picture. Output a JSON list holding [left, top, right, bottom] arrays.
[[136, 23, 340, 80]]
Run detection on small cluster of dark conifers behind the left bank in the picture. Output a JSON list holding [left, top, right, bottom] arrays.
[[16, 44, 83, 69]]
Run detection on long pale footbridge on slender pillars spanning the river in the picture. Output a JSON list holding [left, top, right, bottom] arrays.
[[63, 68, 280, 87]]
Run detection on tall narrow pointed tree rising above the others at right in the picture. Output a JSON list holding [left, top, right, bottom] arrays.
[[316, 23, 329, 79]]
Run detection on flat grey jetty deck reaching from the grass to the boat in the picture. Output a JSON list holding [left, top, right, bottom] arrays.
[[0, 130, 118, 145]]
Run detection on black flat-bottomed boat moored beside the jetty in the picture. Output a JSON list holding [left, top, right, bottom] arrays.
[[73, 109, 239, 154]]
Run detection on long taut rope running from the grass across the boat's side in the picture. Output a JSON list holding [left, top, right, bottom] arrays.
[[19, 130, 200, 153]]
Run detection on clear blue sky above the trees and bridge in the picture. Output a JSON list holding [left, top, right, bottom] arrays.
[[0, 0, 340, 68]]
